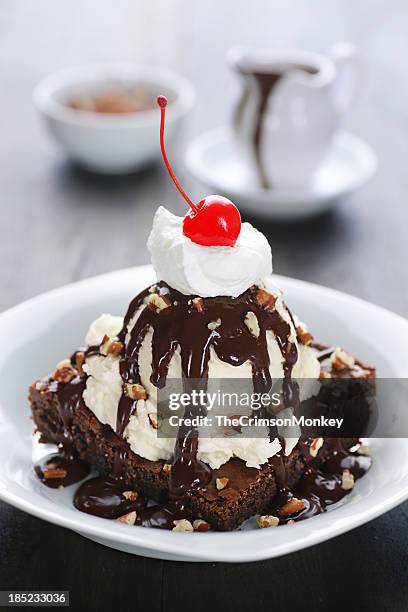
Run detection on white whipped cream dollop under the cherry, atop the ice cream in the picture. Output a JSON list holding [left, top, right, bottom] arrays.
[[147, 206, 272, 297]]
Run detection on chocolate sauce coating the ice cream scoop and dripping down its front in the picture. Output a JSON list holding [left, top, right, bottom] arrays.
[[117, 282, 297, 526]]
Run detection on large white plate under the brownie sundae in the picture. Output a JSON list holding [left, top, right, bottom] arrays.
[[0, 266, 408, 562]]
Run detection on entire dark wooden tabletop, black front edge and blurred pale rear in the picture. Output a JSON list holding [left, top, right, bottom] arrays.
[[0, 0, 408, 612]]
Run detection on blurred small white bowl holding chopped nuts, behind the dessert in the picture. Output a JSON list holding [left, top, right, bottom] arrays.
[[33, 63, 195, 174]]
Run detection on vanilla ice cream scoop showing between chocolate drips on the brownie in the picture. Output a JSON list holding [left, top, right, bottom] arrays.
[[84, 294, 320, 469]]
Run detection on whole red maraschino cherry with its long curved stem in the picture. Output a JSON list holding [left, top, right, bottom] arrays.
[[157, 96, 241, 246]]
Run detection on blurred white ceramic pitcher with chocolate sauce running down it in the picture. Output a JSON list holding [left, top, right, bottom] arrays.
[[228, 43, 359, 188]]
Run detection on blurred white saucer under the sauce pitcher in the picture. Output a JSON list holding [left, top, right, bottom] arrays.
[[186, 128, 377, 220]]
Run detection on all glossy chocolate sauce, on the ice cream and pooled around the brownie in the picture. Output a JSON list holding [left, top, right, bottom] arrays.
[[36, 282, 369, 529]]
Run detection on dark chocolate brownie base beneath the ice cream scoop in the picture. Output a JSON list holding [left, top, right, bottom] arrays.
[[29, 345, 375, 531]]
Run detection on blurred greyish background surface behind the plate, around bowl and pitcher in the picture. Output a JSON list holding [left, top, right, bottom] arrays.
[[0, 0, 408, 315]]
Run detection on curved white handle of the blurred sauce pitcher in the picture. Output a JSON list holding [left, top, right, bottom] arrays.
[[327, 42, 361, 115]]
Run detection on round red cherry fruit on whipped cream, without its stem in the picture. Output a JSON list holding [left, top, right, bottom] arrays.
[[183, 196, 241, 246]]
